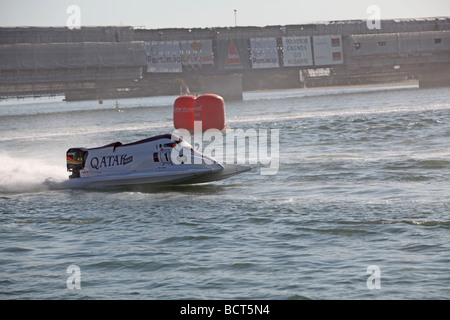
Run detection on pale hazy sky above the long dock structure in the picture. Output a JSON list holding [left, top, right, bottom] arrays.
[[0, 0, 450, 29]]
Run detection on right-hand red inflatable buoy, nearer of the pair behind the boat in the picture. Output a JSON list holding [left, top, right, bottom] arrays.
[[194, 93, 226, 131]]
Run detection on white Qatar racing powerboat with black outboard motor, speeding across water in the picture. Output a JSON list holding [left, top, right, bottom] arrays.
[[57, 134, 251, 188]]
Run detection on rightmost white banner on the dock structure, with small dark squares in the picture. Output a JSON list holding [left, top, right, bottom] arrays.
[[313, 35, 344, 66]]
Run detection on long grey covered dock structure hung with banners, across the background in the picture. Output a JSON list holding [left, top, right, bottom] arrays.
[[0, 17, 450, 100]]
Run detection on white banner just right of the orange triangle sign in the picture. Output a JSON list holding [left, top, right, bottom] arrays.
[[250, 38, 280, 69]]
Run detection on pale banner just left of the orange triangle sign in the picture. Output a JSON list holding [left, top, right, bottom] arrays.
[[180, 39, 214, 69]]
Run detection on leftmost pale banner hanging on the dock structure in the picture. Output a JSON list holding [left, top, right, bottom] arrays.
[[145, 41, 183, 73]]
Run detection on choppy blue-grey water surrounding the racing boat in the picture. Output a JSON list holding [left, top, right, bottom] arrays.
[[0, 86, 450, 299]]
